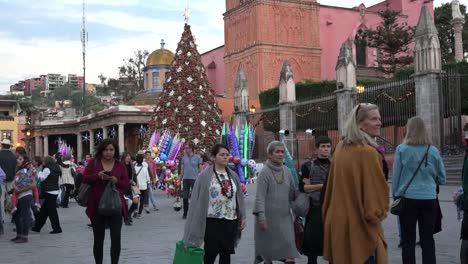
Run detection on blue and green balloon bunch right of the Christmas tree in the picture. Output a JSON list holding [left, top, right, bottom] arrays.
[[221, 122, 256, 189]]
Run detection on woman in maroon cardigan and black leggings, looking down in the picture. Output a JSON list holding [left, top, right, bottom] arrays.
[[83, 139, 129, 264]]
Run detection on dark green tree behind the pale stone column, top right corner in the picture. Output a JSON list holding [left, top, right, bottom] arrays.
[[434, 3, 468, 63]]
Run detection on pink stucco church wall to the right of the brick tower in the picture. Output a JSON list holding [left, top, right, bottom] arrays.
[[320, 0, 434, 80]]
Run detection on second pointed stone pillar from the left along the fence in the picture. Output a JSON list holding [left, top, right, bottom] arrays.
[[278, 61, 298, 159]]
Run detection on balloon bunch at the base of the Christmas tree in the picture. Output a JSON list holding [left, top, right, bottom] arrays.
[[148, 130, 185, 192]]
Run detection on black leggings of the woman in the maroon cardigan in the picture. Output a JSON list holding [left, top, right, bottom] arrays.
[[92, 213, 122, 264]]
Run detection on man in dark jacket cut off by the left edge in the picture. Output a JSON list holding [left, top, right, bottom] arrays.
[[0, 139, 16, 229]]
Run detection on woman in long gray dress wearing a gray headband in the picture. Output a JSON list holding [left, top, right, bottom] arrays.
[[253, 141, 299, 263]]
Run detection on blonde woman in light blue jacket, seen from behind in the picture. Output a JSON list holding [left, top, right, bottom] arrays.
[[392, 117, 445, 264]]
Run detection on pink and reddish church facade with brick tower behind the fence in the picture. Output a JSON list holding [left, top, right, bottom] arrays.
[[202, 0, 434, 112]]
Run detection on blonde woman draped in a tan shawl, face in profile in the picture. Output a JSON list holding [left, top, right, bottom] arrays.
[[322, 104, 389, 264]]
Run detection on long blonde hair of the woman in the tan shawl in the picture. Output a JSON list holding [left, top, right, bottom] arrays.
[[343, 103, 379, 147]]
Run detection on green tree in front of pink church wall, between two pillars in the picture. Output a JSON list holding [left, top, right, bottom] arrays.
[[356, 9, 415, 75]]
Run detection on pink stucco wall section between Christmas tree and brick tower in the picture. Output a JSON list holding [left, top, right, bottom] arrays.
[[201, 46, 225, 95]]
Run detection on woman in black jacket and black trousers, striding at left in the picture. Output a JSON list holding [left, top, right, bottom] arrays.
[[31, 156, 62, 234]]
